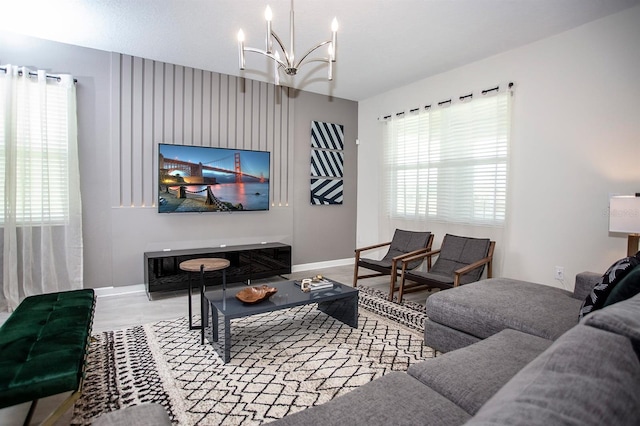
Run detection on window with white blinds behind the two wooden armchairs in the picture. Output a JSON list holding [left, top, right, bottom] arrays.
[[384, 91, 511, 226]]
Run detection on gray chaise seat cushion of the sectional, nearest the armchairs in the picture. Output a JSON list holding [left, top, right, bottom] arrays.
[[426, 278, 582, 340]]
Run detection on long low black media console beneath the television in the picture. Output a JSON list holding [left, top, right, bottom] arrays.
[[144, 243, 291, 299]]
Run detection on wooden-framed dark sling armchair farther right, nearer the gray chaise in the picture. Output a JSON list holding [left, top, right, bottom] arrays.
[[396, 234, 496, 303]]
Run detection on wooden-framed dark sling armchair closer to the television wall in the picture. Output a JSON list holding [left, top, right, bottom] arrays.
[[353, 229, 433, 288]]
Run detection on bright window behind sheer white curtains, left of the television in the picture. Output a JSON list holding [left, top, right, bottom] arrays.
[[0, 72, 70, 225]]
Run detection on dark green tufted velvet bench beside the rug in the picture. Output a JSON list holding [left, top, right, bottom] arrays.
[[0, 289, 95, 424]]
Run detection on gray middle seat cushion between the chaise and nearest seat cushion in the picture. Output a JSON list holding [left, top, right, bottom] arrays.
[[407, 330, 552, 415]]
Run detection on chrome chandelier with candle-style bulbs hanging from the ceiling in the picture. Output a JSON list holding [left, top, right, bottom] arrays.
[[238, 0, 338, 85]]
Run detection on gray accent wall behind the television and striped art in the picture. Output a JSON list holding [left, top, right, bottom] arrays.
[[0, 32, 358, 288]]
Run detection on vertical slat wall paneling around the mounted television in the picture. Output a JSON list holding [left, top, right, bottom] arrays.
[[110, 53, 294, 208]]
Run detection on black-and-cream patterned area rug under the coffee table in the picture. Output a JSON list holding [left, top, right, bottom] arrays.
[[72, 288, 433, 425]]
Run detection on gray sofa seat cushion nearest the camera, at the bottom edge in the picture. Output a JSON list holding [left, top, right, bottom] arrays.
[[271, 372, 471, 426]]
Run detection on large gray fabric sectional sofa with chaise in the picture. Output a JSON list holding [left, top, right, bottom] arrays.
[[274, 273, 640, 426]]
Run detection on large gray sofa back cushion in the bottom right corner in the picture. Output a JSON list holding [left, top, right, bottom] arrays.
[[467, 324, 640, 426]]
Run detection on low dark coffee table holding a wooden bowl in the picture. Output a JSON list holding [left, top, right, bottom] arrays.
[[204, 280, 358, 364]]
